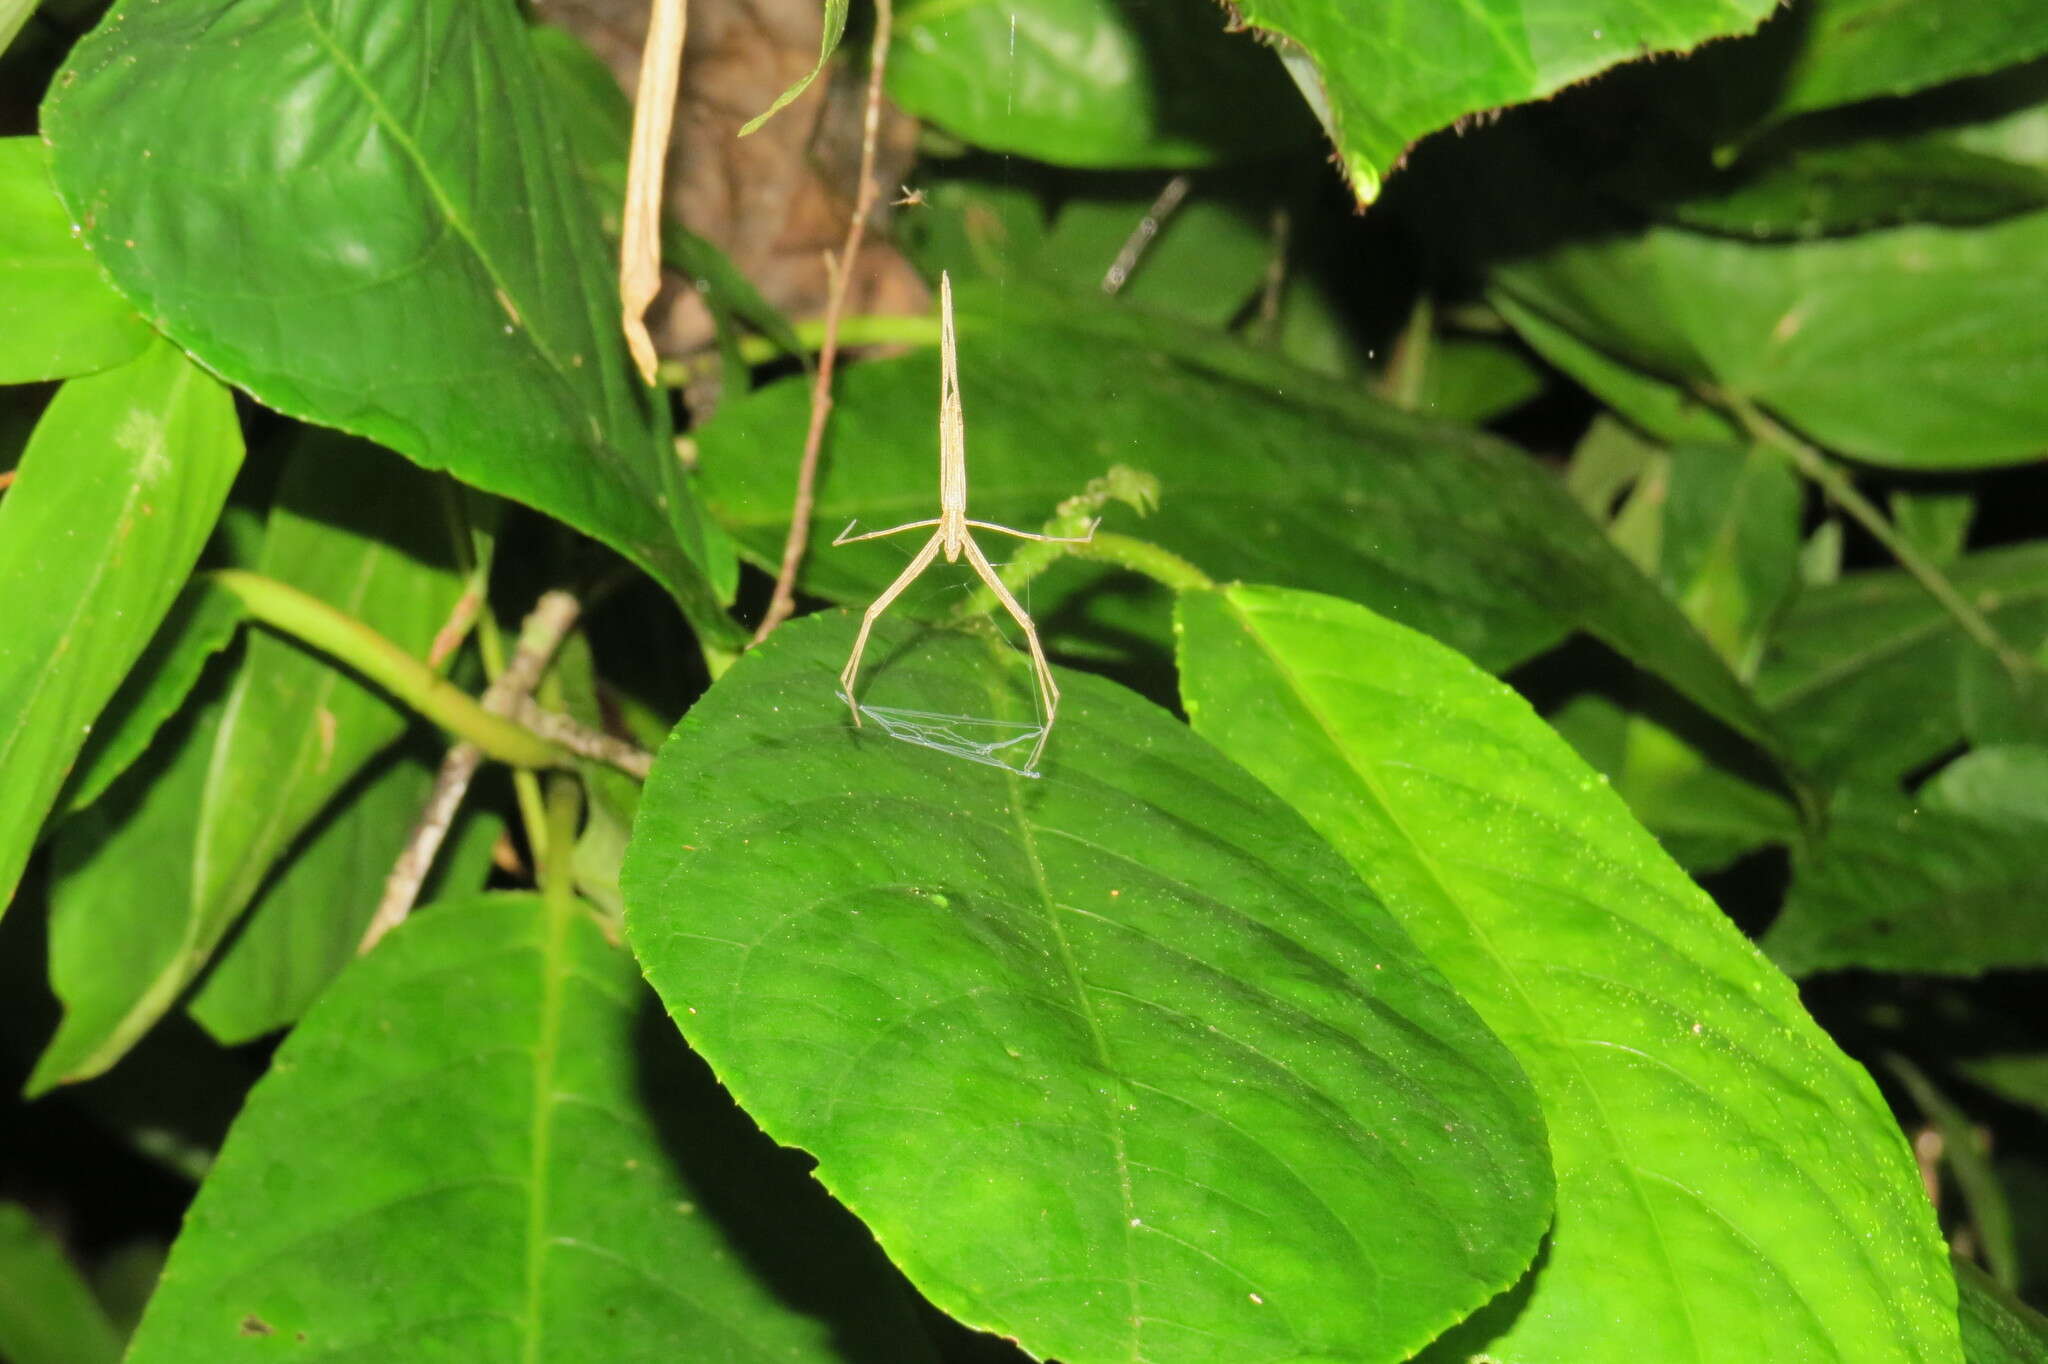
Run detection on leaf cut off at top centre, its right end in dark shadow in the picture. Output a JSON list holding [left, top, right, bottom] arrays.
[[889, 0, 1315, 166]]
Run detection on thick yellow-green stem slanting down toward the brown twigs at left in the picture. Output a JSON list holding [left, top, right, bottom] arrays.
[[213, 569, 571, 768]]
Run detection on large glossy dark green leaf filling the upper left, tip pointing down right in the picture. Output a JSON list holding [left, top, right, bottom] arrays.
[[43, 0, 733, 623]]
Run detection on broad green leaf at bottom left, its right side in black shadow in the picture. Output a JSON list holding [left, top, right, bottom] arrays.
[[129, 897, 926, 1364]]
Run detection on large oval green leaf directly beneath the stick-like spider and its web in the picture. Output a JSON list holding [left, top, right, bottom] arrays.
[[625, 612, 1548, 1364]]
